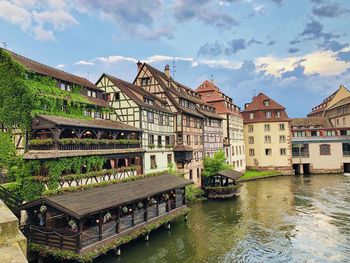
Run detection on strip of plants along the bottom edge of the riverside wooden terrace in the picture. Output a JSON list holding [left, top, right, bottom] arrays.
[[29, 208, 190, 263]]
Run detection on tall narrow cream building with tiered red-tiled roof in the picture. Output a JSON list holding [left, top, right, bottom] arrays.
[[196, 80, 246, 172]]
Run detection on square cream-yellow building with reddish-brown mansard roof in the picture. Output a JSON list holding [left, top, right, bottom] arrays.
[[242, 93, 293, 174]]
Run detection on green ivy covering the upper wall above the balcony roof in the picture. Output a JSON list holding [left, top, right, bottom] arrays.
[[0, 49, 109, 130]]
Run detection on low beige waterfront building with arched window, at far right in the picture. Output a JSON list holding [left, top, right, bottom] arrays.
[[291, 117, 350, 174]]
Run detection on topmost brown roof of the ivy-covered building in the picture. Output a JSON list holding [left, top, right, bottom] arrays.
[[6, 50, 100, 90]]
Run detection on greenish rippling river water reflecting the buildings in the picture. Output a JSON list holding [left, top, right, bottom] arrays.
[[96, 175, 350, 263]]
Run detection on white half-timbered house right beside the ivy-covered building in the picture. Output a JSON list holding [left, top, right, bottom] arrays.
[[96, 74, 175, 173]]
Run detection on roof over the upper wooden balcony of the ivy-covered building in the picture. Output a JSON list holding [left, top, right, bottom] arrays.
[[34, 115, 141, 131]]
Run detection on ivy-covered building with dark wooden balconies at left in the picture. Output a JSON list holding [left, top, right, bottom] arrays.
[[0, 49, 145, 201]]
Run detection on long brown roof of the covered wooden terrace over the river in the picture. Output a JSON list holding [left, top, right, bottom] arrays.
[[22, 175, 192, 218]]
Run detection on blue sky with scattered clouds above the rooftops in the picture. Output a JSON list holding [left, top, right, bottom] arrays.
[[0, 0, 350, 117]]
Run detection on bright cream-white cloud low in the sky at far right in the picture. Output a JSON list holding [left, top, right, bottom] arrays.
[[255, 51, 350, 77]]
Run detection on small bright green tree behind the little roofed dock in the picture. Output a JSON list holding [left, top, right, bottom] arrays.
[[203, 150, 232, 176]]
